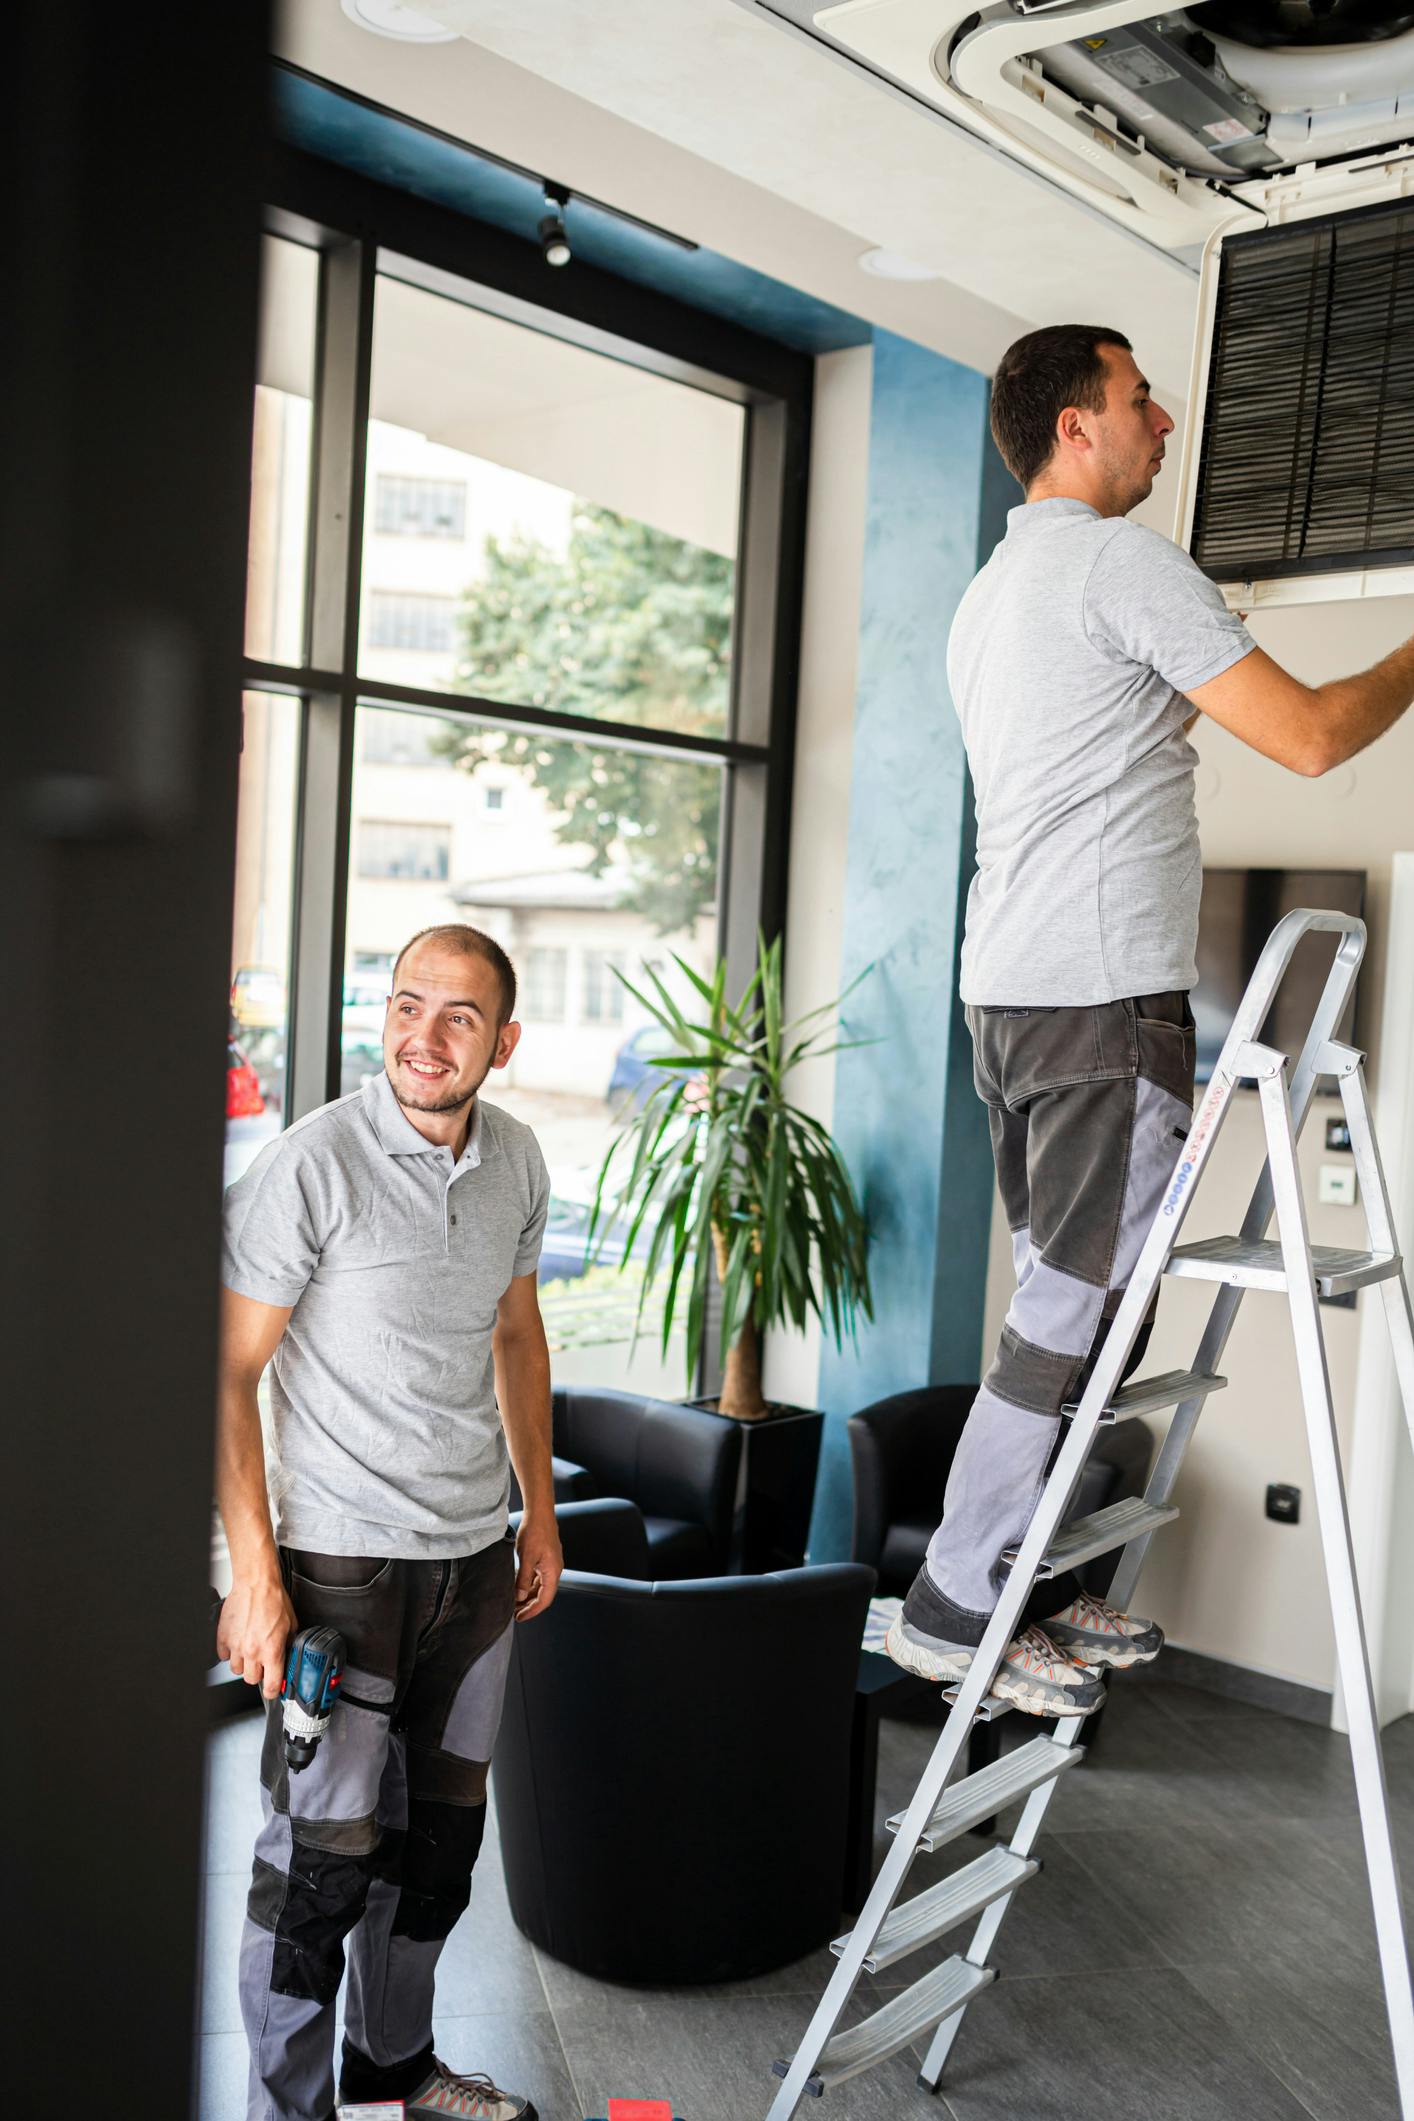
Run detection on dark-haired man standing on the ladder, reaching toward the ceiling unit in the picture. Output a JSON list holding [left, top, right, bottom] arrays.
[[888, 325, 1414, 1716]]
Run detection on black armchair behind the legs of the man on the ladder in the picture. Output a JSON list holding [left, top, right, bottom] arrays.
[[848, 1385, 1153, 1597]]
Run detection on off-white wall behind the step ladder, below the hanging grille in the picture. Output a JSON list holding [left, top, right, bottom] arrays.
[[986, 598, 1414, 1686]]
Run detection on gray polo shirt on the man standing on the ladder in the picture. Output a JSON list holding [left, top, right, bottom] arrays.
[[948, 498, 1253, 1007]]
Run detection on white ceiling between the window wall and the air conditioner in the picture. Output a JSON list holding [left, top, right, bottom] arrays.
[[276, 0, 1196, 397]]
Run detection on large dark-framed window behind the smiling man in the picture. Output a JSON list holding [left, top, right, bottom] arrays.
[[231, 176, 808, 1393]]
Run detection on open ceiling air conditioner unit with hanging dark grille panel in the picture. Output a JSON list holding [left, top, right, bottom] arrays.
[[744, 0, 1414, 609]]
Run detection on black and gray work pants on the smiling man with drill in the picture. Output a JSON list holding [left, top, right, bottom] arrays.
[[240, 1533, 515, 2121]]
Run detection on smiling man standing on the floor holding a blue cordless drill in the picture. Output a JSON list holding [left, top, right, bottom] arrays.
[[216, 927, 560, 2121]]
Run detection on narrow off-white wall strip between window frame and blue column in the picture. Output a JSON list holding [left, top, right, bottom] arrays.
[[765, 346, 873, 1406]]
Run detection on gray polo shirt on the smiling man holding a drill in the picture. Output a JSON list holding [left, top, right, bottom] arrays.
[[223, 1075, 549, 1559]]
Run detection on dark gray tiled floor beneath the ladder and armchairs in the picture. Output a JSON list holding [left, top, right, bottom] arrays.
[[201, 1678, 1414, 2121]]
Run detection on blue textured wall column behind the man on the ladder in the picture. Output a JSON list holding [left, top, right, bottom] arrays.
[[810, 333, 1020, 1561]]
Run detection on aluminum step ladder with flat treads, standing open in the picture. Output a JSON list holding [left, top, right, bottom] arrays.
[[767, 910, 1414, 2121]]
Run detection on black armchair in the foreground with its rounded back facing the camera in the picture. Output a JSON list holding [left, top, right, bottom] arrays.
[[492, 1502, 873, 1985]]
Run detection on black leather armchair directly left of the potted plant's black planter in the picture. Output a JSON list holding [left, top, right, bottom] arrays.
[[538, 1385, 742, 1580]]
